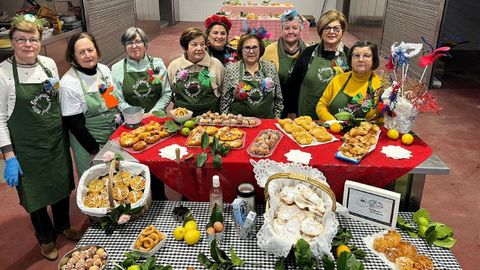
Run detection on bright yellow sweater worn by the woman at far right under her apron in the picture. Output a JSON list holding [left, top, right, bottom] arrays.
[[316, 71, 382, 121]]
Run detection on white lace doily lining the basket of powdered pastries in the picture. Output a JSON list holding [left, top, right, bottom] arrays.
[[250, 159, 338, 259]]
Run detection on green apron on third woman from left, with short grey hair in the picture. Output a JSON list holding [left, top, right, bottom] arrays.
[[123, 56, 162, 112]]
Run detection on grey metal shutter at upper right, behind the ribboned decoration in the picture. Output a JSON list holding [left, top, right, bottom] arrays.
[[381, 0, 445, 84]]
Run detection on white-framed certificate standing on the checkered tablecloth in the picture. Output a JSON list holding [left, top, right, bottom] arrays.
[[343, 180, 400, 229]]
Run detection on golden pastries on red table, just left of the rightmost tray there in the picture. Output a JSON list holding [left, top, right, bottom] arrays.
[[278, 116, 333, 145]]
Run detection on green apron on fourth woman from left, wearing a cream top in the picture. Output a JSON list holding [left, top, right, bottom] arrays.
[[173, 67, 219, 116]]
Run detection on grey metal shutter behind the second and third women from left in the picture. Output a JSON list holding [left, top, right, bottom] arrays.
[[83, 0, 135, 66]]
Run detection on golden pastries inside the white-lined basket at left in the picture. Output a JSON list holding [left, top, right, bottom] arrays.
[[83, 171, 146, 208]]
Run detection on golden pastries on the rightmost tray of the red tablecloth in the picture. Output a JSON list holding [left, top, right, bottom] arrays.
[[339, 122, 380, 159]]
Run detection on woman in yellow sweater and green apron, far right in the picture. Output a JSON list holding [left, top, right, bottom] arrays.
[[316, 41, 382, 121]]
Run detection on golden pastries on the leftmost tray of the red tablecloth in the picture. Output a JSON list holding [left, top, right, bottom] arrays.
[[119, 121, 170, 151]]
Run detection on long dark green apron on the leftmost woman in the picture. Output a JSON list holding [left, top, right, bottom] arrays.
[[7, 58, 75, 213]]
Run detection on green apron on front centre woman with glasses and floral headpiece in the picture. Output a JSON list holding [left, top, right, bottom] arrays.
[[230, 61, 275, 119]]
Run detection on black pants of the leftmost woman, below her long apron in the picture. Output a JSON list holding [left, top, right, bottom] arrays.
[[30, 196, 70, 244]]
